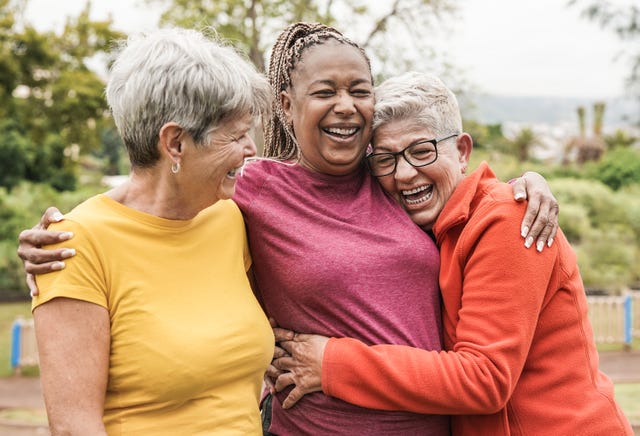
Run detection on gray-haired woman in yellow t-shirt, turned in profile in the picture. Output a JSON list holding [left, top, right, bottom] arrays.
[[33, 29, 273, 435]]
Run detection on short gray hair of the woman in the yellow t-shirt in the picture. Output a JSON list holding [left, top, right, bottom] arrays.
[[106, 28, 271, 167]]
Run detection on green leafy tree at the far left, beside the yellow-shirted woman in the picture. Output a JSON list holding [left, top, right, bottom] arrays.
[[0, 0, 124, 190]]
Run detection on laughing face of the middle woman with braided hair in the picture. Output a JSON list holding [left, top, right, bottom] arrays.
[[281, 40, 374, 175]]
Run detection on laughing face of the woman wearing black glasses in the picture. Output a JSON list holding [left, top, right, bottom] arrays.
[[373, 120, 472, 230]]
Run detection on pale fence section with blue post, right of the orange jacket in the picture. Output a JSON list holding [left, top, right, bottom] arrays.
[[587, 291, 640, 347]]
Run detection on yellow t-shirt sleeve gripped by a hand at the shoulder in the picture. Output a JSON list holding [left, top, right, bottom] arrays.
[[32, 219, 108, 309]]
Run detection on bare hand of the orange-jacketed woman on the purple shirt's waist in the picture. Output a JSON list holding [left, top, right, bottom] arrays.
[[273, 328, 329, 409]]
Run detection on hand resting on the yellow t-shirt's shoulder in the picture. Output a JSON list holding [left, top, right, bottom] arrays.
[[18, 207, 76, 296]]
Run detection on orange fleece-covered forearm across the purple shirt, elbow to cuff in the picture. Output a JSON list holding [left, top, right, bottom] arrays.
[[322, 339, 515, 414]]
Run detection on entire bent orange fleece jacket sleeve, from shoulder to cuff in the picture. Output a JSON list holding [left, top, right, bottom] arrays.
[[322, 202, 557, 414]]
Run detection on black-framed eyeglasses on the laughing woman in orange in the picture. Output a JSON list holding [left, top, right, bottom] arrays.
[[367, 133, 459, 177]]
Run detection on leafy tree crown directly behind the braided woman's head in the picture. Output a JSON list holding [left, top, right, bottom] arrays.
[[146, 0, 462, 85]]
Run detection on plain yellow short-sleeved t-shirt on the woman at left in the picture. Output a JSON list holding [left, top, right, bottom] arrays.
[[33, 195, 274, 435]]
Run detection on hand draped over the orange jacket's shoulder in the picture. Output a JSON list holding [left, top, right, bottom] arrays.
[[512, 171, 560, 251]]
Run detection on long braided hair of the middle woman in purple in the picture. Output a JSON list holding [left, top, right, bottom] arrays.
[[264, 22, 373, 160]]
